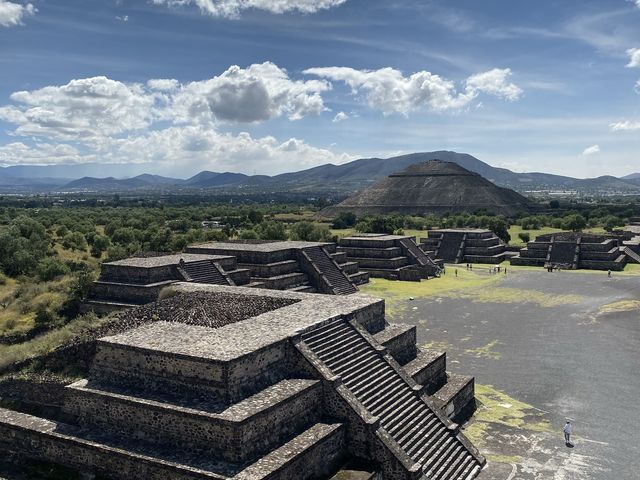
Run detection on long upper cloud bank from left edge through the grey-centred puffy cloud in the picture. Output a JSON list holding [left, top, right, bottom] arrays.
[[0, 62, 331, 142]]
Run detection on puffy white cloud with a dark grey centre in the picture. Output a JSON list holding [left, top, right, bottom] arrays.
[[173, 62, 331, 122]]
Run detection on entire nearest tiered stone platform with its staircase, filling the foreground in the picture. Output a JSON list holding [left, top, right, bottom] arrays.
[[0, 282, 484, 480]]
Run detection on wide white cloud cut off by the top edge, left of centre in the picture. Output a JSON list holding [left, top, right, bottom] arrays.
[[152, 0, 346, 18]]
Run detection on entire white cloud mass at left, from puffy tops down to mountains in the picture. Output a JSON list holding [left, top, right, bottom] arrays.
[[0, 62, 352, 173]]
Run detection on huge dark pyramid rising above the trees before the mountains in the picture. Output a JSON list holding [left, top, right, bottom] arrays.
[[322, 160, 530, 216]]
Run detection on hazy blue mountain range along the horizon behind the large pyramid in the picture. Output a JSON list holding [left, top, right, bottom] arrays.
[[0, 151, 640, 194]]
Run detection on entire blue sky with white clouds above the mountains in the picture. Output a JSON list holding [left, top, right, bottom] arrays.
[[0, 0, 640, 177]]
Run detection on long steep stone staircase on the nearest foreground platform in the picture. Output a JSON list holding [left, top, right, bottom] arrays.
[[302, 318, 482, 480]]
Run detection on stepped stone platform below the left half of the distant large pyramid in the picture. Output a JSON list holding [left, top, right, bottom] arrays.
[[337, 234, 442, 282]]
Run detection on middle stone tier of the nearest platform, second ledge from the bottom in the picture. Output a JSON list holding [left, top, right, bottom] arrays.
[[64, 379, 321, 462]]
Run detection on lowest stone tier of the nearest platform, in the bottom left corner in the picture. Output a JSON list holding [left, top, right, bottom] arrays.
[[0, 409, 346, 480]]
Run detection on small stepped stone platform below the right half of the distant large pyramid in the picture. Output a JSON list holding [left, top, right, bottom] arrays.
[[420, 228, 507, 265]]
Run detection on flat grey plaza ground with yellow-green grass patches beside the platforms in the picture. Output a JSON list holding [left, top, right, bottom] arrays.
[[361, 265, 640, 480]]
